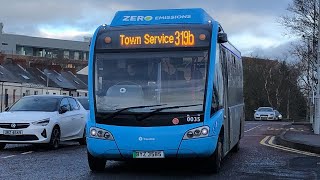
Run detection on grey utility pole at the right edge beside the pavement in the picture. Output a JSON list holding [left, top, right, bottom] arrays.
[[313, 0, 320, 134]]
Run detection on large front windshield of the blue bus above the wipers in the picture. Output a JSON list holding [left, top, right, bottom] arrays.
[[94, 50, 208, 113]]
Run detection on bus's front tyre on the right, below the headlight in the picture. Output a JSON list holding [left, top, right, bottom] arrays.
[[206, 137, 223, 173]]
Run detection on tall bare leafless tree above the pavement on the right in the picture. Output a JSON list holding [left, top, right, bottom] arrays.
[[279, 0, 319, 121]]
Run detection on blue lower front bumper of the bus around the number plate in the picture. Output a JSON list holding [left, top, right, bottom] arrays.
[[87, 136, 218, 160]]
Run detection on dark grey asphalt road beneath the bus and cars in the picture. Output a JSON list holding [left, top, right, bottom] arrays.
[[0, 121, 320, 180]]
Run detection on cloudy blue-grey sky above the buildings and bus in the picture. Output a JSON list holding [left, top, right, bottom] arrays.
[[0, 0, 296, 59]]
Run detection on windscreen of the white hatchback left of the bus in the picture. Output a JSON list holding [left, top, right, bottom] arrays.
[[9, 97, 59, 112]]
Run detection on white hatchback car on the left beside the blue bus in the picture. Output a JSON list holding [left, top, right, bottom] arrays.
[[0, 95, 87, 150]]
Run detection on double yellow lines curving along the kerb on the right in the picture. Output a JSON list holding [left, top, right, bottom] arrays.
[[260, 136, 320, 157]]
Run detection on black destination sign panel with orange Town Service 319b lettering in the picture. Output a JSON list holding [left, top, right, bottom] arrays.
[[96, 25, 211, 49]]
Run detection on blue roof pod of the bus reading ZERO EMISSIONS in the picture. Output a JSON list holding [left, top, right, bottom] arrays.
[[110, 8, 214, 26]]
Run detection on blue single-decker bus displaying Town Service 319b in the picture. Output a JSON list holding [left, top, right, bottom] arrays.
[[86, 8, 244, 172]]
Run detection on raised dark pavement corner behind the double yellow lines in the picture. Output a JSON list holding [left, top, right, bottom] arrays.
[[275, 123, 320, 154]]
